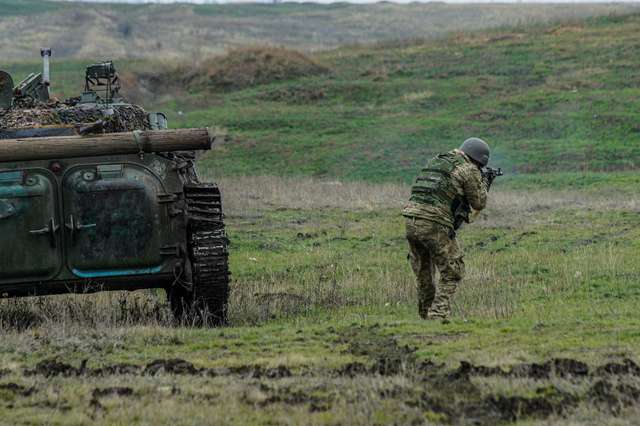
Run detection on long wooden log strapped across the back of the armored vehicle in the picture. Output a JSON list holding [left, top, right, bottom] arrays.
[[0, 129, 213, 162]]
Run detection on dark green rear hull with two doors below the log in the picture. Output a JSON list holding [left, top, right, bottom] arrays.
[[0, 154, 193, 297]]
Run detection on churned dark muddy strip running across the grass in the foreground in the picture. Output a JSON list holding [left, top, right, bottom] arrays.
[[0, 325, 640, 425]]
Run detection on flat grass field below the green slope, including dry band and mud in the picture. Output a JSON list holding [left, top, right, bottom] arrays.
[[0, 176, 640, 425]]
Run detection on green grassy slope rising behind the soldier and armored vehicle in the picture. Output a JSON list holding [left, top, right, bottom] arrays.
[[3, 10, 640, 187]]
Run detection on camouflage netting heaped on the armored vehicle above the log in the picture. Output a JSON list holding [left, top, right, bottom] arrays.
[[0, 101, 150, 133]]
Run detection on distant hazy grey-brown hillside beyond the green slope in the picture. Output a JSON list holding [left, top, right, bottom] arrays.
[[0, 0, 637, 62]]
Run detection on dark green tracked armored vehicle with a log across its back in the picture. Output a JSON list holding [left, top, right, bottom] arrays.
[[0, 49, 229, 325]]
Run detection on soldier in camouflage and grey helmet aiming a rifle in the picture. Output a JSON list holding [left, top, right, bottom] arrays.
[[402, 138, 490, 321]]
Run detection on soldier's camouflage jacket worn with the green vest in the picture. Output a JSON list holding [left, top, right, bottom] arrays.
[[402, 149, 487, 228]]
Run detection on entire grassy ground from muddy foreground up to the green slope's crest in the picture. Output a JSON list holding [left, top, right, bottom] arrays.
[[0, 3, 640, 425]]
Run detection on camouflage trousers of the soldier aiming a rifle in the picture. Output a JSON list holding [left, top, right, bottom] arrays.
[[406, 218, 464, 319]]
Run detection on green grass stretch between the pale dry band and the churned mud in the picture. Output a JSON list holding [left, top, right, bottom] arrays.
[[2, 179, 640, 367]]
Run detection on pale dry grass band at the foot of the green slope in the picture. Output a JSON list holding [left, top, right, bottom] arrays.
[[215, 175, 640, 220]]
